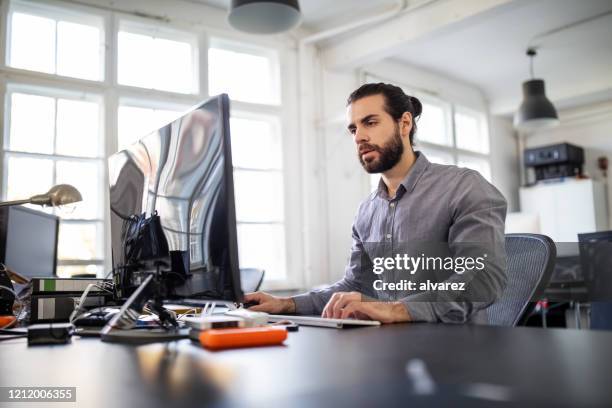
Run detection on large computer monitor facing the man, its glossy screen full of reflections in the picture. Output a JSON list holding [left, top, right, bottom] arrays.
[[108, 94, 242, 302]]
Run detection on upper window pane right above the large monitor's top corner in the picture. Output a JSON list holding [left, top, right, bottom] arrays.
[[208, 48, 280, 104]]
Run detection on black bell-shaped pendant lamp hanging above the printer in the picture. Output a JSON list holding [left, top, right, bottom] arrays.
[[514, 79, 559, 131]]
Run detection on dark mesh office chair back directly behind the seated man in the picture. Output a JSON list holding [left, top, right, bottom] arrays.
[[487, 234, 557, 326]]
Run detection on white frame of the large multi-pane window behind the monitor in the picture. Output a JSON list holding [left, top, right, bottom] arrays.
[[0, 0, 304, 289]]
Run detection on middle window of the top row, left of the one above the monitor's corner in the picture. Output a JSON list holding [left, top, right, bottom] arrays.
[[117, 21, 198, 94]]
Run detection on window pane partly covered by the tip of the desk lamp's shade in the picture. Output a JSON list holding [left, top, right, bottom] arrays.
[[56, 160, 103, 219]]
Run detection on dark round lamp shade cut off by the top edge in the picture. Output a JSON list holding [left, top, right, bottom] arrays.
[[228, 0, 302, 34]]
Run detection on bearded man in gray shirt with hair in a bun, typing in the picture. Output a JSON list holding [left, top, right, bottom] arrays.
[[245, 83, 506, 323]]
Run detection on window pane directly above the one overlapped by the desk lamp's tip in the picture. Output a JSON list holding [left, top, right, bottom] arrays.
[[56, 99, 101, 157]]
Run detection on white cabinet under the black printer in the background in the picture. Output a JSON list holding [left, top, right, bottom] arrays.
[[520, 179, 608, 242]]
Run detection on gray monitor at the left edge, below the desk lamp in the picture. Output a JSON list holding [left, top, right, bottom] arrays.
[[0, 206, 59, 277]]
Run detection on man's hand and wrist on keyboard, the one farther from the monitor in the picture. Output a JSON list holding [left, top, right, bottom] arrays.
[[321, 292, 410, 323]]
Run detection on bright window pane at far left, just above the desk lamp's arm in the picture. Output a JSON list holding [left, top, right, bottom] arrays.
[[6, 156, 53, 201]]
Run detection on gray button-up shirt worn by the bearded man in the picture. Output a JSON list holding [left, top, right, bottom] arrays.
[[293, 152, 506, 323]]
